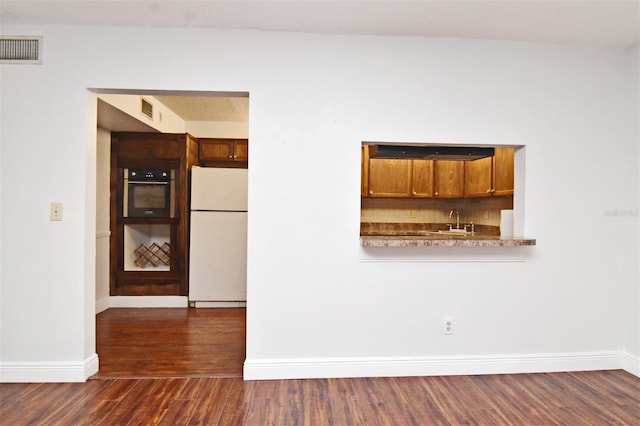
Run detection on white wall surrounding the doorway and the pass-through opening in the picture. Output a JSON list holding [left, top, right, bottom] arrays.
[[0, 27, 640, 380]]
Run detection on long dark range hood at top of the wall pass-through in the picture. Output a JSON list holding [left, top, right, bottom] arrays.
[[369, 145, 495, 161]]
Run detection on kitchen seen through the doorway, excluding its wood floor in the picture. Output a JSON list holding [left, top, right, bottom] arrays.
[[96, 93, 248, 313]]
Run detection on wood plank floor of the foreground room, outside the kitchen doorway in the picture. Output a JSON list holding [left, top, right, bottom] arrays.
[[0, 370, 640, 426]]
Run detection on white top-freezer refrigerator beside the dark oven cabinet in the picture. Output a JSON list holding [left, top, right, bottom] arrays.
[[189, 166, 248, 307]]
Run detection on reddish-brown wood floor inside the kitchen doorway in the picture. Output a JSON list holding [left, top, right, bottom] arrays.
[[96, 308, 246, 378]]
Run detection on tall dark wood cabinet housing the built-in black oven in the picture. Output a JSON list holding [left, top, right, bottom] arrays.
[[109, 132, 198, 296]]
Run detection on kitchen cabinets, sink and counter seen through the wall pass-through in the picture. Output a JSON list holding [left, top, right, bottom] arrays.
[[360, 142, 535, 247]]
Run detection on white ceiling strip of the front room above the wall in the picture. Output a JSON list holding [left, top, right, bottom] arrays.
[[0, 0, 640, 47]]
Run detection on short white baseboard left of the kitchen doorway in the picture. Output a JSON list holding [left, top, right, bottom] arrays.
[[0, 354, 99, 383]]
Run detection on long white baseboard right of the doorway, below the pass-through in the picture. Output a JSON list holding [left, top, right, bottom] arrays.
[[244, 352, 638, 380]]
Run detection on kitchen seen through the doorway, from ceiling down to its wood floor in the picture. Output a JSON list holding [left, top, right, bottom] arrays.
[[95, 91, 249, 377]]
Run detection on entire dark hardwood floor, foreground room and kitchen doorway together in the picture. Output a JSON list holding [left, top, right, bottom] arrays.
[[0, 309, 640, 426]]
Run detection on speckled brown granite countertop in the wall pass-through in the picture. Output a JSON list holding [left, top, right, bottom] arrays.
[[360, 223, 536, 247]]
